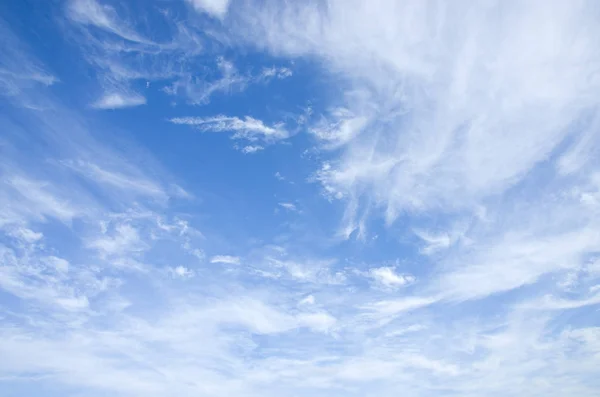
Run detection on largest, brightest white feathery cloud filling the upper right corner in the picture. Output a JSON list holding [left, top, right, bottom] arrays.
[[236, 0, 600, 226]]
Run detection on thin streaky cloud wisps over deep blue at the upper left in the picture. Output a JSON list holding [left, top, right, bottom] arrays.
[[66, 0, 204, 109]]
